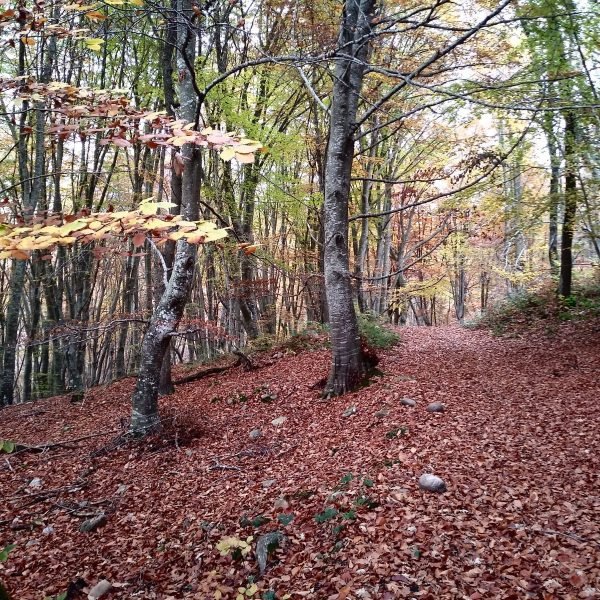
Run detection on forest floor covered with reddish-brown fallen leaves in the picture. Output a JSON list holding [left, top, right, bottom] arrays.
[[0, 321, 600, 600]]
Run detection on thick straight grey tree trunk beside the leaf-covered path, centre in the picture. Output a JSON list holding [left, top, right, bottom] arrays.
[[324, 0, 374, 396]]
